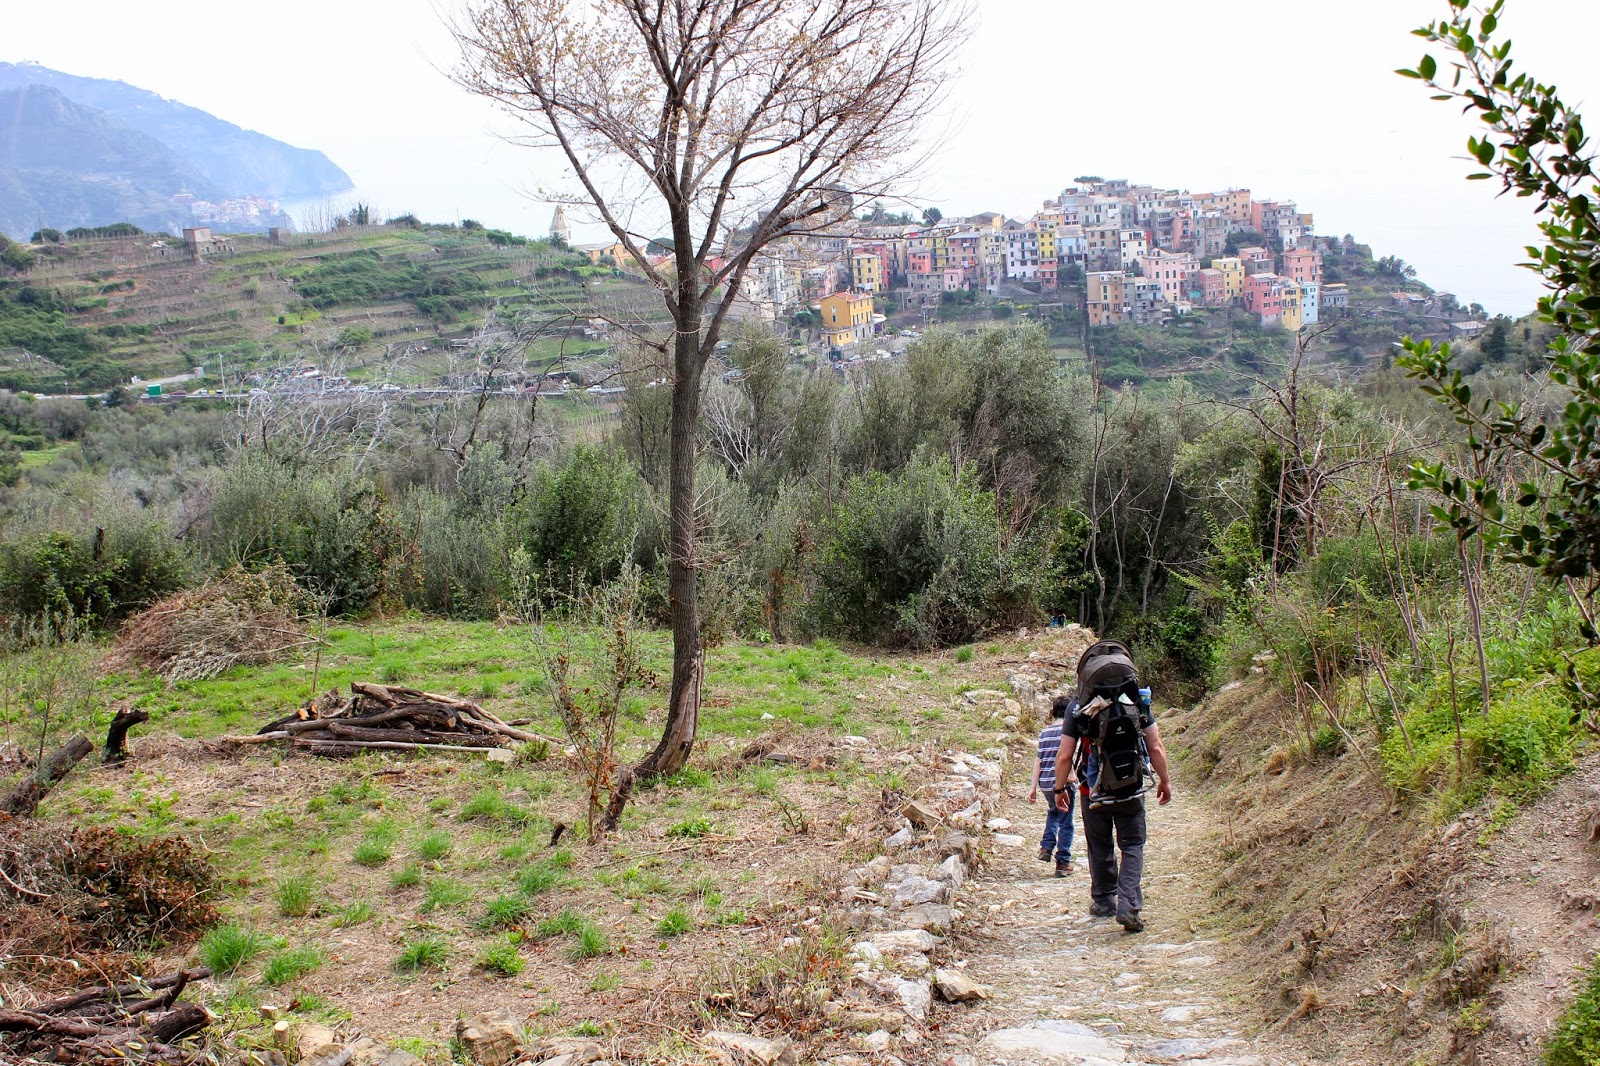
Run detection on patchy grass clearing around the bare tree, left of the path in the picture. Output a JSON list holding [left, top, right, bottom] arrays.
[[0, 619, 1029, 1064]]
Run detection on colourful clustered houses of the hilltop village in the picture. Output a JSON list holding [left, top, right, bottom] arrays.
[[566, 178, 1486, 352]]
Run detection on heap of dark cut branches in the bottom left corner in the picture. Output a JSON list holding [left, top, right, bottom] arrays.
[[0, 968, 211, 1066]]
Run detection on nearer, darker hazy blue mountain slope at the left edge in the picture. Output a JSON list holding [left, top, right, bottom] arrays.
[[0, 85, 219, 237]]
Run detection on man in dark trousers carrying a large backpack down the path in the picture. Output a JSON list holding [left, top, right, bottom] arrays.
[[1054, 640, 1173, 933]]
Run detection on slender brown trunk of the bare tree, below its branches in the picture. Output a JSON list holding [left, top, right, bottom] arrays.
[[634, 303, 706, 779]]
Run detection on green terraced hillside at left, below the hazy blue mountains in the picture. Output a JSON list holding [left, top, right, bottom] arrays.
[[0, 226, 654, 392]]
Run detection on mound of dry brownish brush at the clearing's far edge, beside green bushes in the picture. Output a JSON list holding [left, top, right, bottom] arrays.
[[104, 563, 315, 683]]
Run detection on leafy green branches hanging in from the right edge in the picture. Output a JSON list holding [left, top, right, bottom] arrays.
[[1397, 0, 1600, 630]]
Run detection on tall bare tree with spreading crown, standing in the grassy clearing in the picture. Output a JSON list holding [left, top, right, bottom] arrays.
[[453, 0, 970, 793]]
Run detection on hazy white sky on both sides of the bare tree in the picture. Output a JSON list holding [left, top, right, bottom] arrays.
[[0, 0, 1600, 314]]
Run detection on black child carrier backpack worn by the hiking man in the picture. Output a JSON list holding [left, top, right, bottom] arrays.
[[1078, 640, 1152, 807]]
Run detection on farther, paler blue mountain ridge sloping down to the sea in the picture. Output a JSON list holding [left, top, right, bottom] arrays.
[[0, 62, 352, 200]]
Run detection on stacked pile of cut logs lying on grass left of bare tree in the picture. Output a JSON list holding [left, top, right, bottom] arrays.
[[222, 682, 554, 755]]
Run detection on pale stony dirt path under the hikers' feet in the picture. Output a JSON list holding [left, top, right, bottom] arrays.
[[938, 771, 1320, 1066]]
